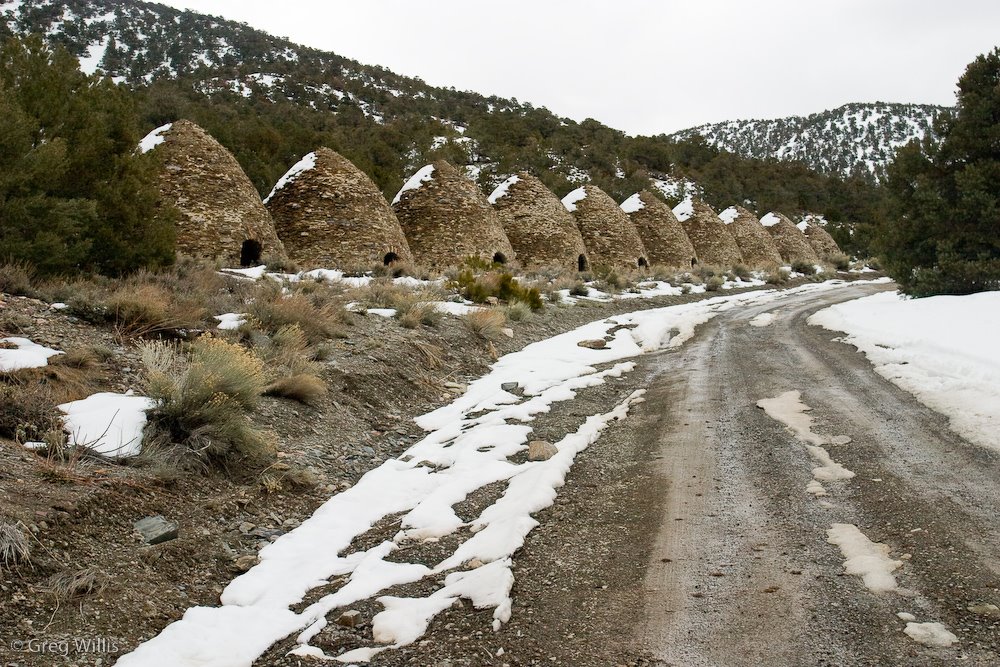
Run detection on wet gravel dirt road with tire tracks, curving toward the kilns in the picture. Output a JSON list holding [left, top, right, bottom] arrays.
[[632, 286, 1000, 666]]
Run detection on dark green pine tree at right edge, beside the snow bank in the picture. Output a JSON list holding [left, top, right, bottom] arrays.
[[879, 49, 1000, 296]]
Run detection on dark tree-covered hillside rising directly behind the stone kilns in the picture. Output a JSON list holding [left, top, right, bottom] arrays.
[[0, 0, 881, 237]]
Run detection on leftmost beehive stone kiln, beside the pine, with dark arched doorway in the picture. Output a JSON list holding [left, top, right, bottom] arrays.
[[140, 120, 286, 266]]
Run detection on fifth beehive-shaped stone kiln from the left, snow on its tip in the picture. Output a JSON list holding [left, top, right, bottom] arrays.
[[562, 185, 649, 269]]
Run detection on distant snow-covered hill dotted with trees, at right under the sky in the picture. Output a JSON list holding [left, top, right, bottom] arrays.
[[673, 102, 945, 178]]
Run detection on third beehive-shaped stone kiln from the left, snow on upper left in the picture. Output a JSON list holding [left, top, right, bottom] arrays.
[[392, 160, 515, 269]]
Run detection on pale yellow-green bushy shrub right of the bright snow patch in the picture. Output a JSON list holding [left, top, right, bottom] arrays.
[[141, 337, 270, 462]]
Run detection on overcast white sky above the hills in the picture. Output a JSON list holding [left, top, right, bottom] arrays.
[[158, 0, 1000, 134]]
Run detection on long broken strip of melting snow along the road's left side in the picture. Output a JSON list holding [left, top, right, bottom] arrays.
[[118, 281, 880, 667]]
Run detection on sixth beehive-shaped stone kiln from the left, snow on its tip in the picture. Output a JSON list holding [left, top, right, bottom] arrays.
[[621, 190, 698, 269]]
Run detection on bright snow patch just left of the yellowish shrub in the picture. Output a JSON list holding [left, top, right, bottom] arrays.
[[58, 392, 155, 458]]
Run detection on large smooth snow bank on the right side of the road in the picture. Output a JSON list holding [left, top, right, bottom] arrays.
[[809, 292, 1000, 449]]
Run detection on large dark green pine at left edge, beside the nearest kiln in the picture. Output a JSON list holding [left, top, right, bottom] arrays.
[[0, 37, 174, 274]]
